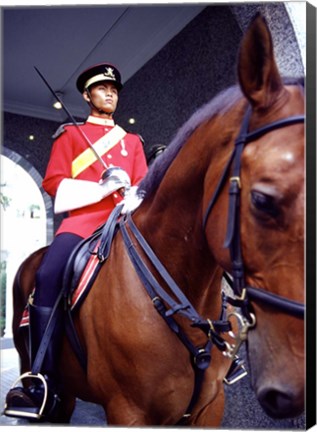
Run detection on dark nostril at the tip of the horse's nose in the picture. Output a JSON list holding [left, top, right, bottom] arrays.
[[258, 388, 295, 418]]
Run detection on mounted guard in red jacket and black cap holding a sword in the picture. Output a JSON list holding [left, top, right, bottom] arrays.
[[4, 63, 147, 419]]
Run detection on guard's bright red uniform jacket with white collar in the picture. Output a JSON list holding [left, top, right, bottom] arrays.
[[43, 116, 147, 237]]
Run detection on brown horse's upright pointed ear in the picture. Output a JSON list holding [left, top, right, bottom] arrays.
[[238, 14, 282, 109]]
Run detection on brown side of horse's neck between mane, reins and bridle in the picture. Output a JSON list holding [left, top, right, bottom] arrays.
[[136, 126, 227, 309]]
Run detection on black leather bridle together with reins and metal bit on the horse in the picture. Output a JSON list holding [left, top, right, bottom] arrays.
[[119, 103, 305, 419]]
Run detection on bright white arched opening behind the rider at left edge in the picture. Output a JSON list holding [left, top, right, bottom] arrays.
[[0, 150, 53, 337]]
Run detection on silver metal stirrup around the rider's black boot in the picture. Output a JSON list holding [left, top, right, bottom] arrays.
[[3, 372, 48, 420]]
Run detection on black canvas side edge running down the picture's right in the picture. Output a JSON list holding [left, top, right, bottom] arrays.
[[306, 3, 317, 429]]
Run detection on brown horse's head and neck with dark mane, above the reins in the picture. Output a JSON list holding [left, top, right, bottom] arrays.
[[138, 11, 304, 417]]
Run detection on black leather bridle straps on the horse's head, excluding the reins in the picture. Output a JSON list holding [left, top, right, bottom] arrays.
[[203, 107, 305, 321]]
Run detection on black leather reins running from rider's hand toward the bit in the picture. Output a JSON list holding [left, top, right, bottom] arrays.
[[119, 213, 232, 424]]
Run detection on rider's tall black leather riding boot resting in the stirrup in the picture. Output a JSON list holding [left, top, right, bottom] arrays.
[[3, 304, 63, 422]]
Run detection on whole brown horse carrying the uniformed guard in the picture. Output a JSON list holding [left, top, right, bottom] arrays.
[[8, 16, 305, 427]]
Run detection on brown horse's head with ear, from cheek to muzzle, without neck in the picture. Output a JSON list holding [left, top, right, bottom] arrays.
[[202, 16, 305, 418]]
